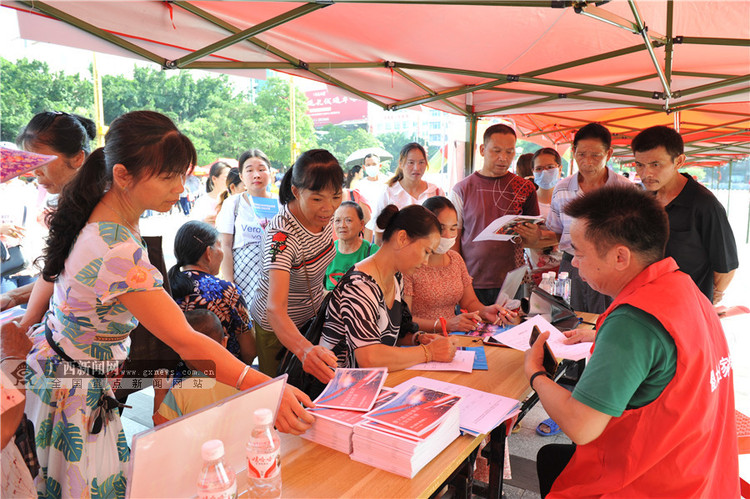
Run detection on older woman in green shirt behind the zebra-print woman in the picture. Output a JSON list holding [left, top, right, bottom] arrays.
[[326, 201, 378, 291]]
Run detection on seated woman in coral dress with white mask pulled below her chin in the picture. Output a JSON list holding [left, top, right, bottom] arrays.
[[404, 196, 518, 333]]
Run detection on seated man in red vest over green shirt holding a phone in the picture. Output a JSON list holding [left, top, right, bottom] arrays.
[[524, 187, 740, 498]]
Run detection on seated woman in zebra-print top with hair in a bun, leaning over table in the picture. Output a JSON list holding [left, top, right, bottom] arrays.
[[320, 204, 456, 371]]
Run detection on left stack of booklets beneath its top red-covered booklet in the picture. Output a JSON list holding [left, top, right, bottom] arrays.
[[302, 388, 398, 454]]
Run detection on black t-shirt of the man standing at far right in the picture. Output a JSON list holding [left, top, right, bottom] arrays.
[[665, 173, 739, 300]]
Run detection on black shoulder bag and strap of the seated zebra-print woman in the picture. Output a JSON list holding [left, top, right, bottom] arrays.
[[277, 267, 354, 400]]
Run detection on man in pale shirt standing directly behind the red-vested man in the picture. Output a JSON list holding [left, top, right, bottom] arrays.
[[546, 123, 632, 314]]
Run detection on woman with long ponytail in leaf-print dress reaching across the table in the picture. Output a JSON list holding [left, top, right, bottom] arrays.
[[26, 111, 313, 497]]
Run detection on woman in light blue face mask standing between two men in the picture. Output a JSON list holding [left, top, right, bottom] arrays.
[[516, 147, 562, 284]]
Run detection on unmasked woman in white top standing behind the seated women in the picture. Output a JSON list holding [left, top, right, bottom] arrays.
[[367, 142, 445, 244]]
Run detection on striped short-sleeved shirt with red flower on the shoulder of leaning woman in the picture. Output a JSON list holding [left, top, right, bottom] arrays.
[[250, 205, 336, 331]]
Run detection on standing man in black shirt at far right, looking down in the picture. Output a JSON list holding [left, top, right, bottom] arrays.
[[630, 126, 739, 304]]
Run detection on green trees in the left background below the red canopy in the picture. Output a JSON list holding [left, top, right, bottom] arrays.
[[0, 59, 318, 168]]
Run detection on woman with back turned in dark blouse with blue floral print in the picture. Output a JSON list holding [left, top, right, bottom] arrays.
[[169, 220, 255, 364]]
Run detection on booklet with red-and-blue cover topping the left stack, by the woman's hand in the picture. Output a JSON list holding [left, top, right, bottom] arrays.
[[314, 367, 388, 412]]
